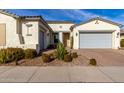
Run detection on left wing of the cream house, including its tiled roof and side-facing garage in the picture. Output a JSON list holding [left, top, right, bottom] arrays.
[[0, 10, 54, 53]]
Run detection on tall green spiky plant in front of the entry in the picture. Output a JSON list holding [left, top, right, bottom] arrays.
[[57, 42, 66, 60]]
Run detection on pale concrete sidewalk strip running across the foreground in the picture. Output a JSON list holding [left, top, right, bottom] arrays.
[[0, 66, 124, 82]]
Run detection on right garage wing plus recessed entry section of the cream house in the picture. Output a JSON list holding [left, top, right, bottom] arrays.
[[47, 17, 122, 49]]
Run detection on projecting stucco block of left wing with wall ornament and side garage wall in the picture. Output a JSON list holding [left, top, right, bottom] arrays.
[[22, 21, 51, 51]]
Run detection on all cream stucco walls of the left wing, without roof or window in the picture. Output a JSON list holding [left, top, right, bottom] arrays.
[[0, 13, 53, 51]]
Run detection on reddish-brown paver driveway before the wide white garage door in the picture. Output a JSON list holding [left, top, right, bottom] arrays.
[[77, 49, 124, 66]]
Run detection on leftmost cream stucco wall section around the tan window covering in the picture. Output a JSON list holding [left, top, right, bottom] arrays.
[[0, 13, 19, 48]]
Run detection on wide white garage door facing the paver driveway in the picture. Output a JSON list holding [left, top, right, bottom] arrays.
[[79, 32, 112, 48]]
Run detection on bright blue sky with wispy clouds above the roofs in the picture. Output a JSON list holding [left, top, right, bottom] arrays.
[[7, 9, 124, 25]]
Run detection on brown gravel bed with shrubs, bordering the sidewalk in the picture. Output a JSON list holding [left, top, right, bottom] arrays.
[[0, 55, 88, 66]]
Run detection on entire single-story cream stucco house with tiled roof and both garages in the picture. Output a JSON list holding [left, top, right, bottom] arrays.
[[0, 10, 122, 53]]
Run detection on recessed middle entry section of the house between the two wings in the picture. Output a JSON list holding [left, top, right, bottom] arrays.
[[47, 21, 74, 47]]
